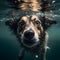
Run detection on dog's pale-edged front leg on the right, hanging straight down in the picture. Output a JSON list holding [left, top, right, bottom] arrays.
[[41, 32, 48, 60]]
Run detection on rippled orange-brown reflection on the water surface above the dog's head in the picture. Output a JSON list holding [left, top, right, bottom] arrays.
[[18, 0, 42, 11]]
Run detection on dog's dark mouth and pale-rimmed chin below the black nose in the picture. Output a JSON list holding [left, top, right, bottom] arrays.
[[21, 38, 39, 48]]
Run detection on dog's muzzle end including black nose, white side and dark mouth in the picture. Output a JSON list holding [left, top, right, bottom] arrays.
[[21, 29, 39, 48]]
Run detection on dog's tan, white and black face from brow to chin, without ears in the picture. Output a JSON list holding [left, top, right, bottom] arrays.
[[17, 15, 43, 47]]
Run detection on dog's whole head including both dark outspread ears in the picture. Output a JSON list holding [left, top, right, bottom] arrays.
[[6, 15, 56, 47]]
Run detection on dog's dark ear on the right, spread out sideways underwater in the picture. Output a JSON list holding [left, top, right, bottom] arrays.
[[42, 17, 57, 30]]
